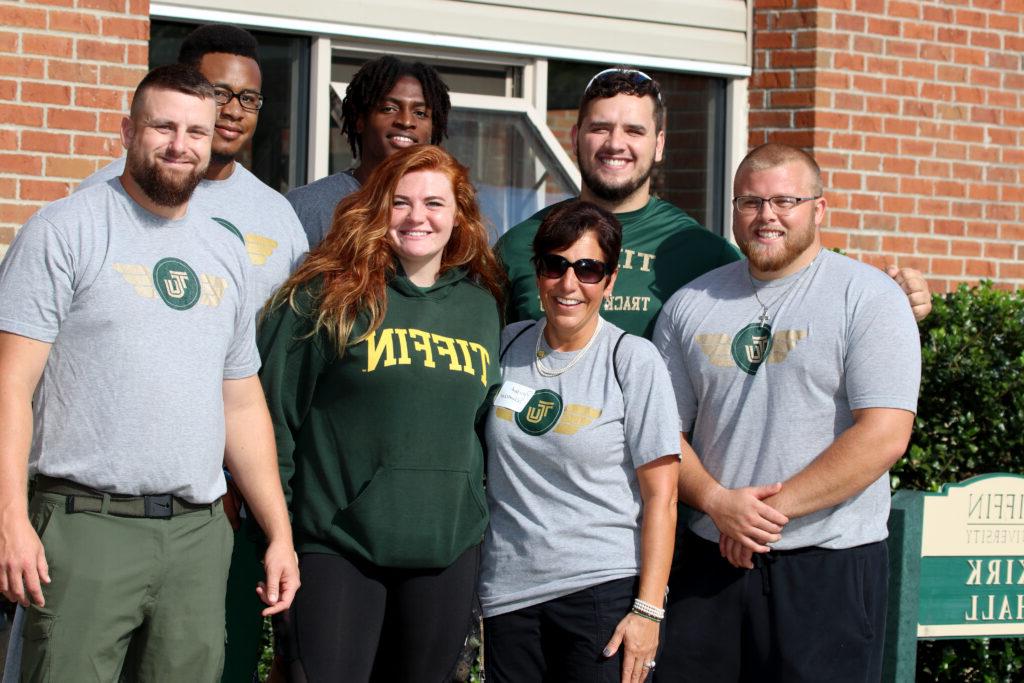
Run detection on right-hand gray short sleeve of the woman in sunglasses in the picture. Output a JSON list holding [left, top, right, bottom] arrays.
[[612, 335, 679, 468]]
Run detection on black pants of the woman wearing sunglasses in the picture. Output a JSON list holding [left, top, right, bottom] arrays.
[[483, 577, 637, 683]]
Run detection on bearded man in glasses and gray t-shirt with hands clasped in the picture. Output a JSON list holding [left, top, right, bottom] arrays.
[[653, 144, 921, 681]]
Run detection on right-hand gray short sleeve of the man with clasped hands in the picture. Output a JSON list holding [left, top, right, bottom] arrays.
[[845, 281, 921, 413]]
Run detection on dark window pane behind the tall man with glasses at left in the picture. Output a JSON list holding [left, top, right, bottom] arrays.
[[150, 19, 309, 193]]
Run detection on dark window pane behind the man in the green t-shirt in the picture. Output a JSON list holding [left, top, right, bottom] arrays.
[[548, 59, 725, 234]]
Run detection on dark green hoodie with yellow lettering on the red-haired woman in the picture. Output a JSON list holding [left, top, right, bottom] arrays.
[[258, 268, 501, 568]]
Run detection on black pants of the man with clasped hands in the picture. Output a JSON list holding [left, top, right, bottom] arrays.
[[655, 532, 889, 683]]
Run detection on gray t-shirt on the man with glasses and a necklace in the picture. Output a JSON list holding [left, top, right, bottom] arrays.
[[654, 250, 921, 550]]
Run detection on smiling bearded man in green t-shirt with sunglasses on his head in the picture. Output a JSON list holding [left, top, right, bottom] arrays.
[[496, 68, 931, 338]]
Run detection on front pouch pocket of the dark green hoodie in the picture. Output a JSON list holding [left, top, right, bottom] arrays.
[[334, 467, 487, 568]]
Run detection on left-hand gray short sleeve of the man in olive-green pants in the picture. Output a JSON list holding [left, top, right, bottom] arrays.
[[0, 213, 76, 343]]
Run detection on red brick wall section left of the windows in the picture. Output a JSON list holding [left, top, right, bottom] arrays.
[[0, 0, 150, 256]]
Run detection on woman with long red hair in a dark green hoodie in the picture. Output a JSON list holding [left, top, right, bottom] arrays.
[[259, 144, 501, 683]]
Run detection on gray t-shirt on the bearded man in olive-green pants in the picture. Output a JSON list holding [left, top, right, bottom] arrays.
[[0, 179, 259, 503]]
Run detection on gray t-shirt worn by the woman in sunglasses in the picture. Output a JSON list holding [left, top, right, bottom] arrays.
[[480, 322, 679, 616]]
